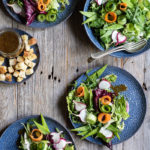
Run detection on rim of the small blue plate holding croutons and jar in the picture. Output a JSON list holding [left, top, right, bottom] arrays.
[[0, 28, 41, 85]]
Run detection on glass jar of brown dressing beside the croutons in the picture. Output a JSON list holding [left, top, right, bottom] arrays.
[[0, 29, 24, 58]]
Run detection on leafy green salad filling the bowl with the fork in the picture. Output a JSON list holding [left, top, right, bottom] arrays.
[[81, 0, 150, 49]]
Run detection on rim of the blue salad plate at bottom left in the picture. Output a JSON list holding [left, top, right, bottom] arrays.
[[0, 115, 76, 150]]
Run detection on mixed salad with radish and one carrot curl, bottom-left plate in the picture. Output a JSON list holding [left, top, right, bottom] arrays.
[[19, 115, 74, 150]]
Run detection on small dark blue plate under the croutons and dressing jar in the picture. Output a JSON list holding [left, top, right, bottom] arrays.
[[0, 29, 40, 84]]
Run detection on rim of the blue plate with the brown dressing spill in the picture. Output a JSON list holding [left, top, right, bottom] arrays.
[[68, 65, 147, 145]]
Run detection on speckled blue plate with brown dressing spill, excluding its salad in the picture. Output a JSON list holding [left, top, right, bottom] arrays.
[[71, 66, 146, 145]]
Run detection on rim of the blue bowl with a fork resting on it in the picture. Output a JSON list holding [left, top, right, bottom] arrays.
[[83, 0, 150, 58]]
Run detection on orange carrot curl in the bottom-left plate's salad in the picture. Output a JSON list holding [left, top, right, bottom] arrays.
[[30, 129, 43, 142]]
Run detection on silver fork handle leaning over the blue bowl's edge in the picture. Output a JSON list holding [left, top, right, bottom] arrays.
[[91, 47, 125, 59]]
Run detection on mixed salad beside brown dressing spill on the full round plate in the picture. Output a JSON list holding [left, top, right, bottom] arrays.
[[67, 65, 129, 148]]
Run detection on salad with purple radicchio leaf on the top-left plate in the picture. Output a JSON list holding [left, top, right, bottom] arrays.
[[7, 0, 69, 25]]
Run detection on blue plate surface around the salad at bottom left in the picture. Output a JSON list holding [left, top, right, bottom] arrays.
[[0, 116, 76, 150]]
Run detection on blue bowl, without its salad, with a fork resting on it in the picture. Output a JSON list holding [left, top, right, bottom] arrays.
[[83, 0, 150, 58]]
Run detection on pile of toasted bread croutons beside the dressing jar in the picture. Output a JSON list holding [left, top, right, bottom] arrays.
[[0, 35, 37, 82]]
